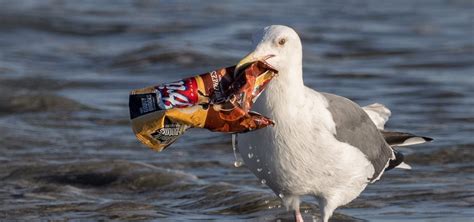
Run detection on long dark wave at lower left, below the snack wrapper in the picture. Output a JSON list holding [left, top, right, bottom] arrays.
[[4, 161, 196, 190]]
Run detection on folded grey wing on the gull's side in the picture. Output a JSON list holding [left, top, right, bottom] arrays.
[[322, 93, 394, 182]]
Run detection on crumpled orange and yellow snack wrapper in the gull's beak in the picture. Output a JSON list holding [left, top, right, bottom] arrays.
[[129, 61, 278, 151]]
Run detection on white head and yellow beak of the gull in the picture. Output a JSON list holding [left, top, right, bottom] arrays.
[[235, 25, 302, 76]]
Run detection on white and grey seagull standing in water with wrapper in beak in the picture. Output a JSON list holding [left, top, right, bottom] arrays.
[[236, 25, 431, 222]]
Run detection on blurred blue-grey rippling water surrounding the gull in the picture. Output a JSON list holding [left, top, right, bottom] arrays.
[[0, 0, 474, 221]]
